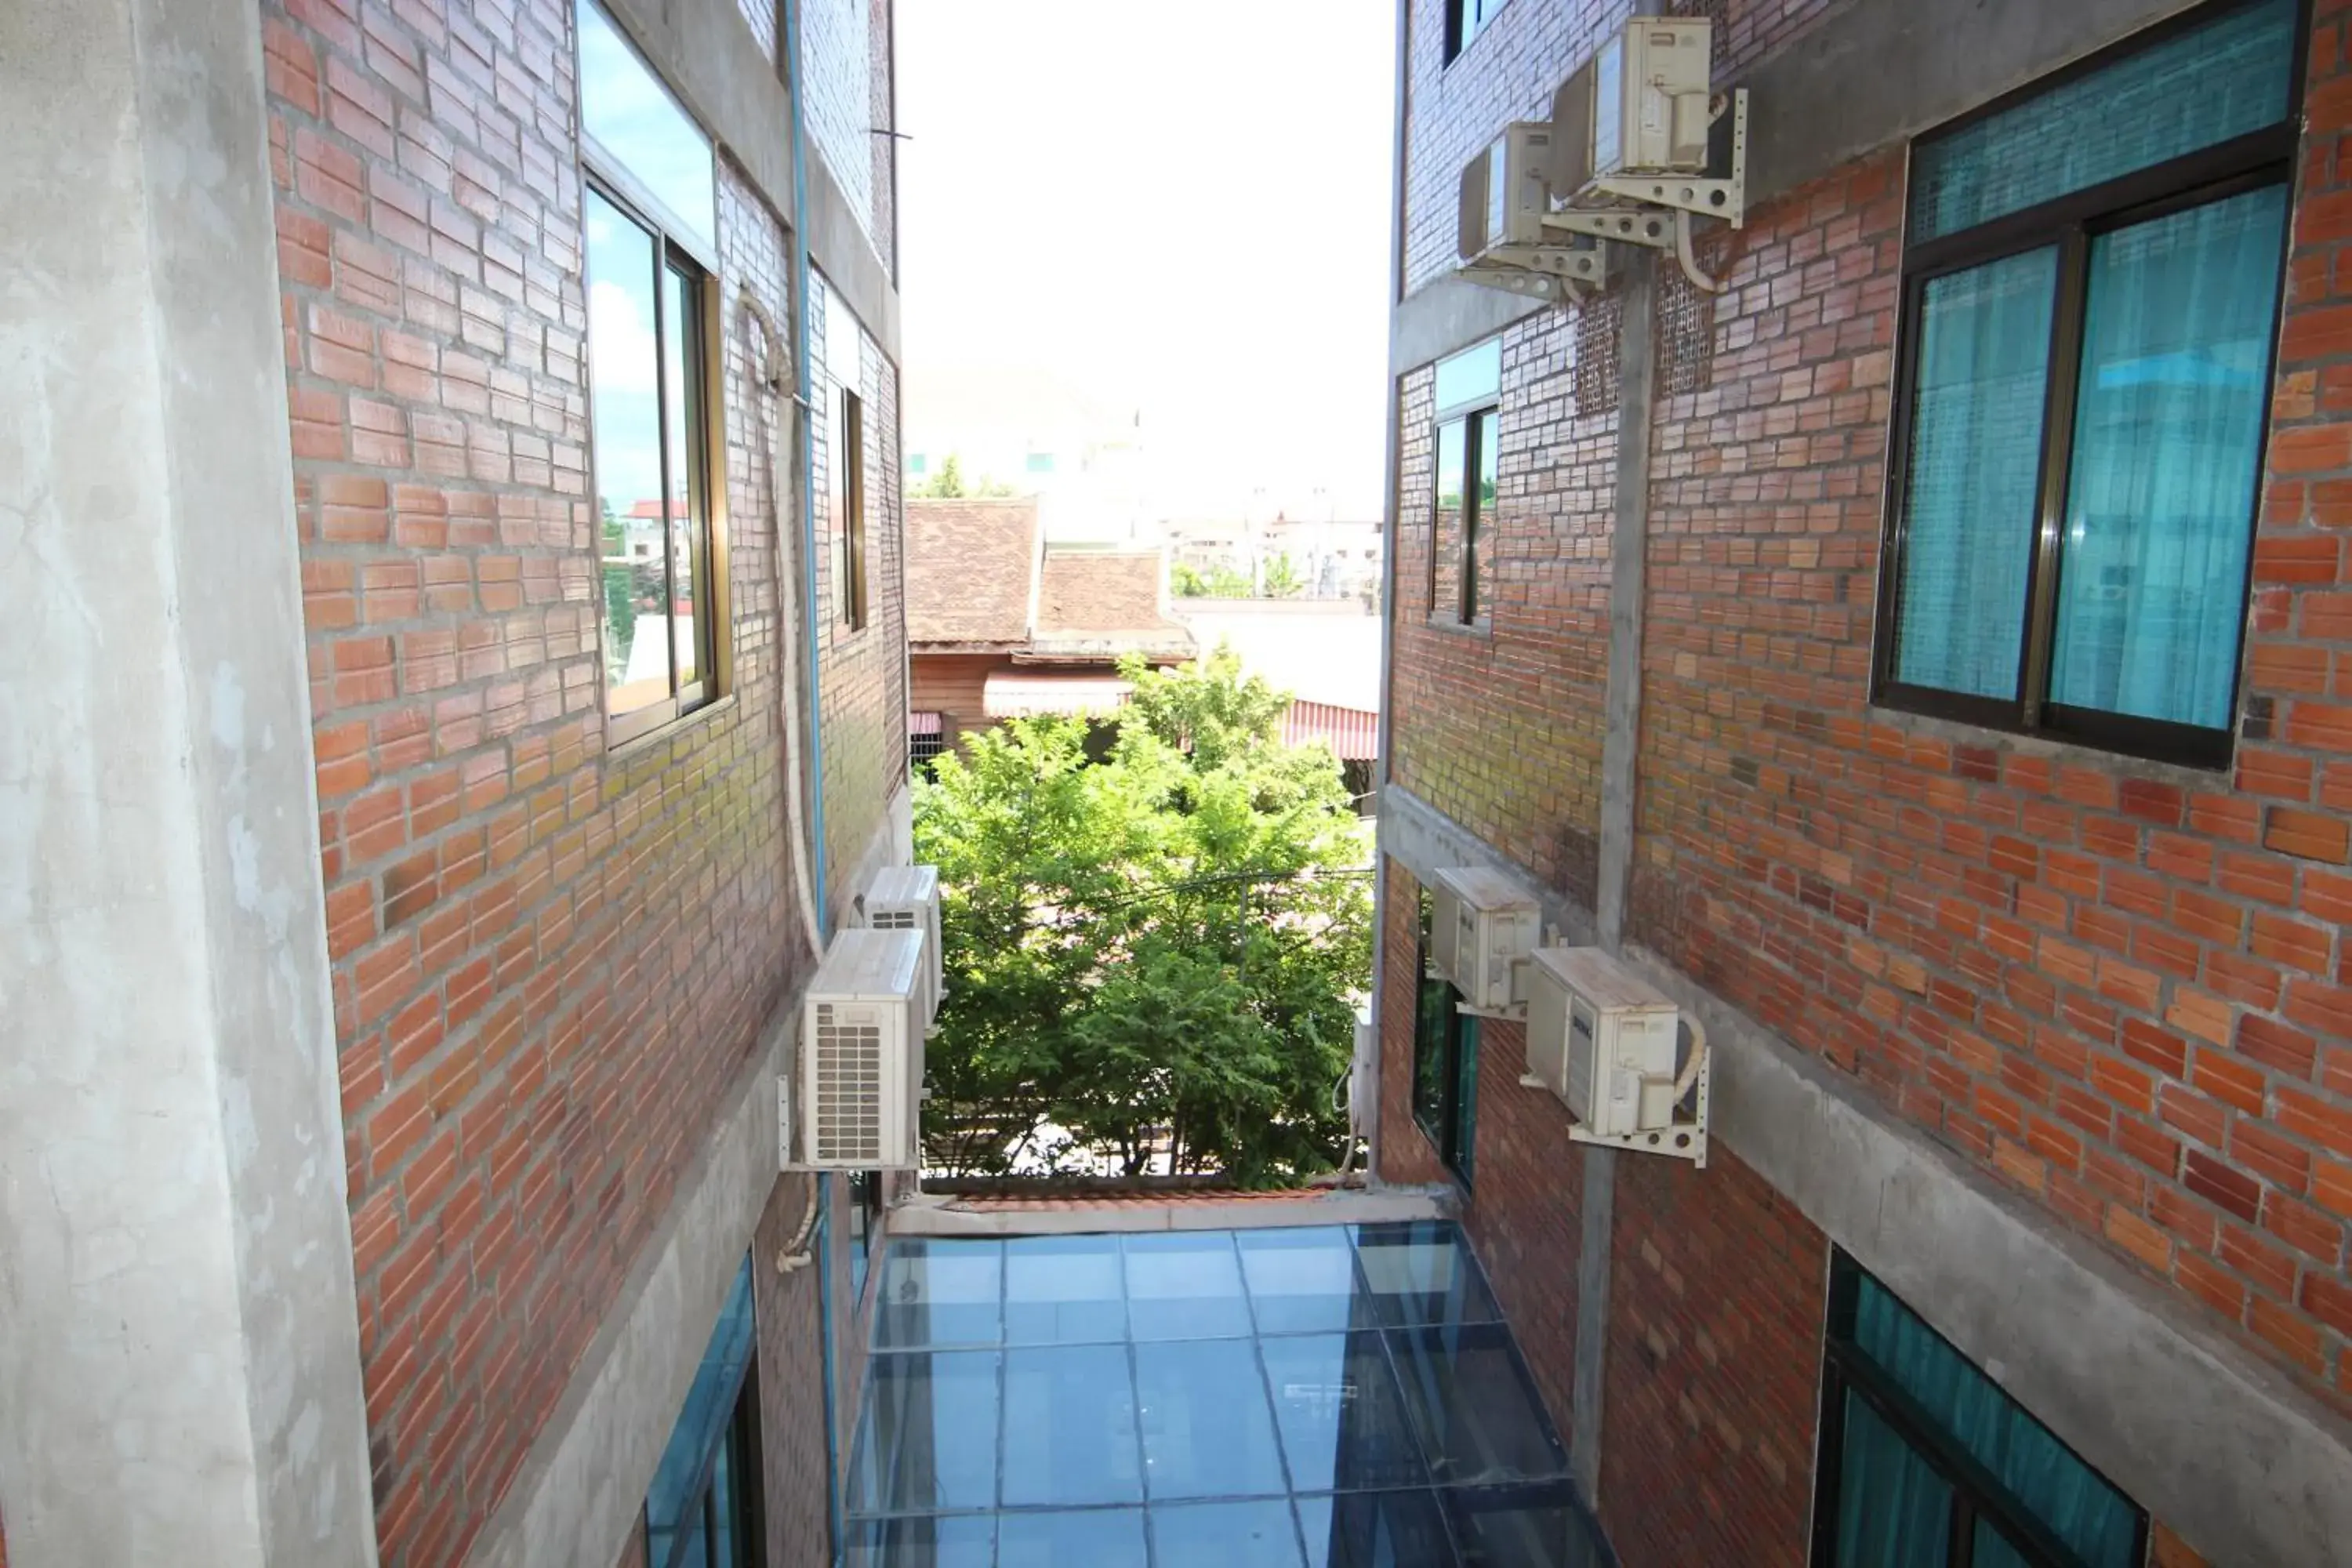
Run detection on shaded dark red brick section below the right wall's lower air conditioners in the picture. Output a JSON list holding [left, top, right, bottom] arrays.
[[1599, 1147, 1830, 1568]]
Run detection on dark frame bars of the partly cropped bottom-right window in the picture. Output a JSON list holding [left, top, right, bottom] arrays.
[[1806, 1246, 2150, 1568]]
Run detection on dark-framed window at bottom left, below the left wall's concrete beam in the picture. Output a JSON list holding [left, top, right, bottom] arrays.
[[644, 1258, 767, 1568]]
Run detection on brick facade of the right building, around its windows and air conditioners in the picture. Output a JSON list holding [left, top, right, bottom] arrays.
[[1383, 0, 2352, 1563]]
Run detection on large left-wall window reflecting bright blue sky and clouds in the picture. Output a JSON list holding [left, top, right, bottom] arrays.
[[576, 0, 727, 741]]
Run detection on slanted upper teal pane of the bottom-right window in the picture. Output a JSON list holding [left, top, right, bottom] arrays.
[[1839, 1274, 2140, 1568]]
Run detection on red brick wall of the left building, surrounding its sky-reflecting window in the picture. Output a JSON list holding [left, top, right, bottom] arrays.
[[263, 0, 901, 1563]]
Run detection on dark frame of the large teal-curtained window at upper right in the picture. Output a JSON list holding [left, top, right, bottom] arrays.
[[1870, 0, 2310, 771]]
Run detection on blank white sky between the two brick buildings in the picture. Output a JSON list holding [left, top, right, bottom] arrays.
[[898, 0, 1397, 517]]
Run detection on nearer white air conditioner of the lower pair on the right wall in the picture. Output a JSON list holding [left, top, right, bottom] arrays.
[[1524, 947, 1708, 1166]]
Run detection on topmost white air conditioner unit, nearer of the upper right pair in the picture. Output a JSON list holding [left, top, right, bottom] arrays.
[[1545, 16, 1715, 196]]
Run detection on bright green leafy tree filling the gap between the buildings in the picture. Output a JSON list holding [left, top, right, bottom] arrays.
[[915, 649, 1371, 1182]]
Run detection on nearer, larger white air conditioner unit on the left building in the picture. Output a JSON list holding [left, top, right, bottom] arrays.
[[795, 926, 924, 1171]]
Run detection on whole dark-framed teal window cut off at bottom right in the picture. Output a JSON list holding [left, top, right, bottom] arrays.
[[1813, 1250, 2147, 1568]]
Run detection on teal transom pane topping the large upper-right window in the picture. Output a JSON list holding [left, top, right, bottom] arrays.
[[1910, 0, 2298, 245]]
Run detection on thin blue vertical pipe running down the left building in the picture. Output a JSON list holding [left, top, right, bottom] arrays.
[[776, 0, 847, 1568]]
